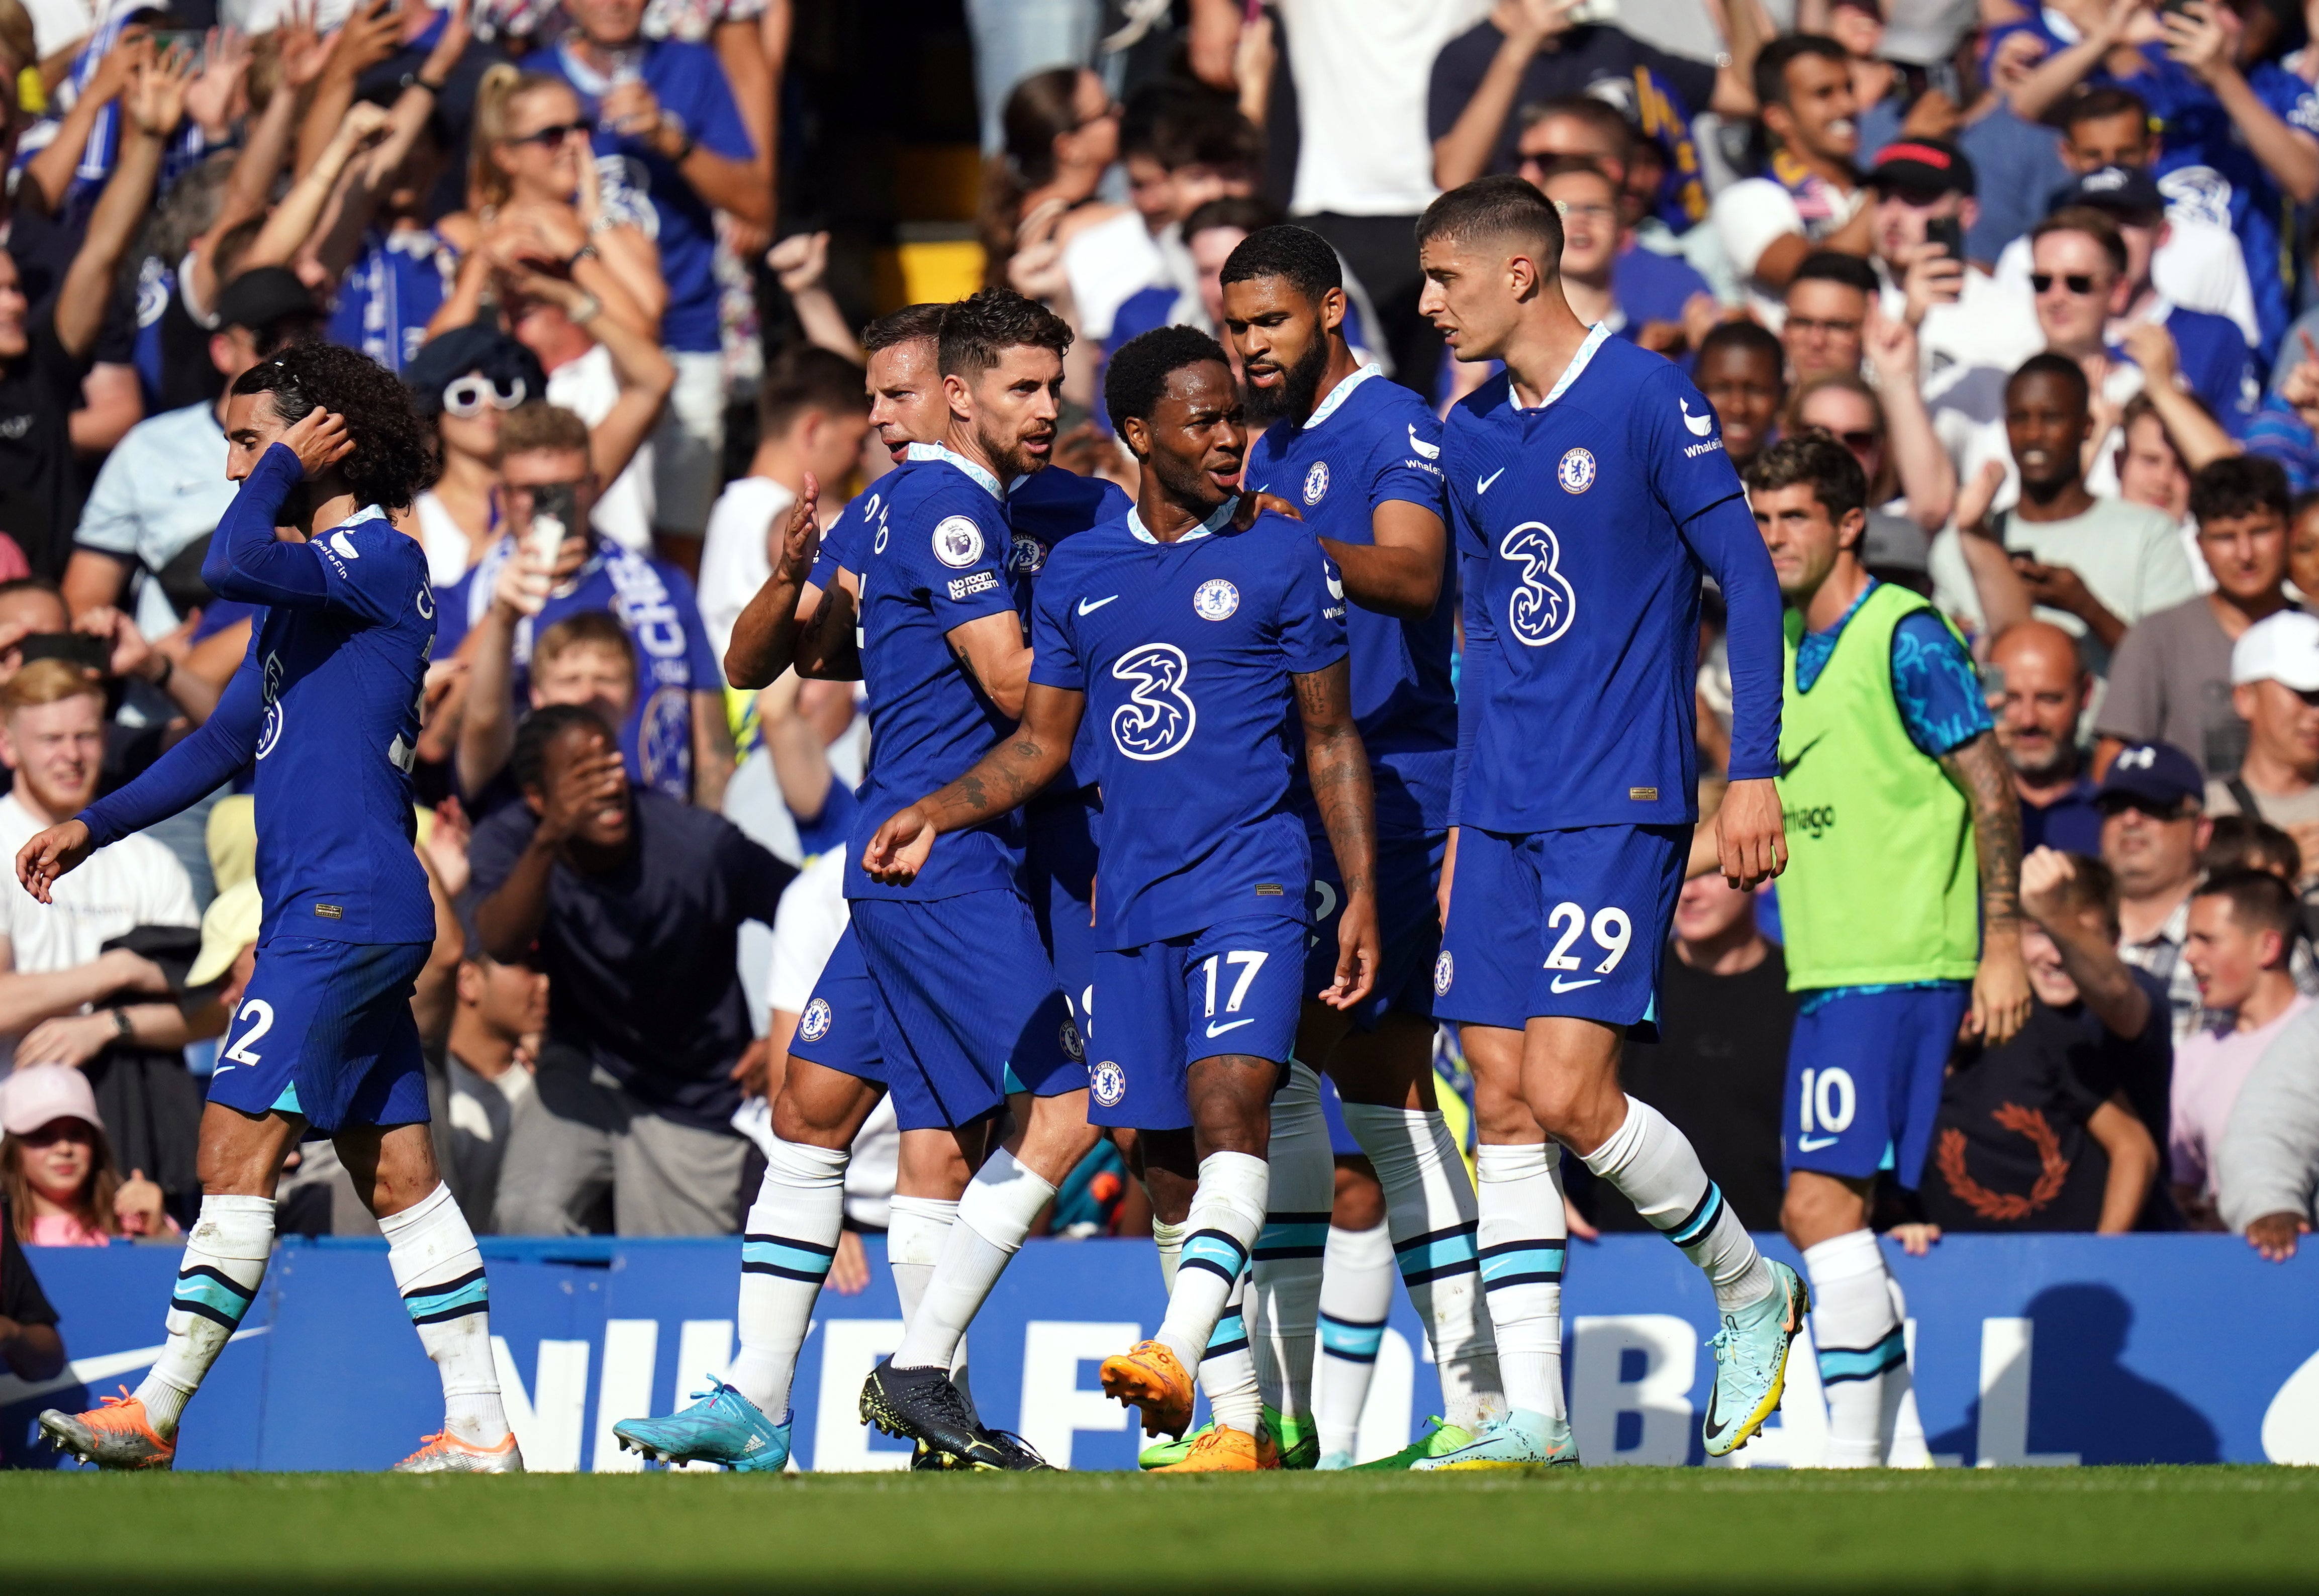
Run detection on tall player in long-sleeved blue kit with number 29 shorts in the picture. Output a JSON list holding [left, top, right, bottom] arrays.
[[1417, 176, 1809, 1468]]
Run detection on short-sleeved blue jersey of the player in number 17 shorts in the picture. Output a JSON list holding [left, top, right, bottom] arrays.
[[1030, 504, 1345, 946]]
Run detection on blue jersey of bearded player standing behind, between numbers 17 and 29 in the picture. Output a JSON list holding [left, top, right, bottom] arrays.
[[1243, 364, 1457, 835]]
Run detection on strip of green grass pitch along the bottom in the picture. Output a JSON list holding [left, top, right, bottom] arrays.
[[0, 1468, 2319, 1596]]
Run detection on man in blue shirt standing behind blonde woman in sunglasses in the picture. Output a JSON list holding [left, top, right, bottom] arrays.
[[540, 0, 772, 538]]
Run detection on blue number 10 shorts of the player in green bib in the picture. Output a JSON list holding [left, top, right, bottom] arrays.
[[1779, 981, 1974, 1190]]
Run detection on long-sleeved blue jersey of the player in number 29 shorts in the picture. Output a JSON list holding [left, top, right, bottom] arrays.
[[1442, 327, 1781, 833]]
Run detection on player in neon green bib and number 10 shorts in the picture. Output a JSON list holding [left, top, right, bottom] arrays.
[[1746, 432, 2029, 1468]]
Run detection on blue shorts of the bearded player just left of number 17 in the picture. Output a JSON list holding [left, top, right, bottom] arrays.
[[848, 888, 1088, 1130]]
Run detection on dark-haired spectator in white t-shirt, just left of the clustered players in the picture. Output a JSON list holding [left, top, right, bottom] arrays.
[[698, 346, 869, 659]]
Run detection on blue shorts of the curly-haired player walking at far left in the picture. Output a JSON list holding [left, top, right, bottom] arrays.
[[209, 935, 434, 1134]]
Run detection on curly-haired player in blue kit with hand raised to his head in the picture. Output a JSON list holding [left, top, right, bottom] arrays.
[[16, 343, 524, 1473]]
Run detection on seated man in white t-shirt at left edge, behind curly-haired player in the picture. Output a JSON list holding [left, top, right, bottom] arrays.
[[0, 659, 202, 1067]]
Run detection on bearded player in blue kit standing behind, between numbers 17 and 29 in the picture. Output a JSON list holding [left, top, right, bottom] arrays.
[[1222, 225, 1505, 1468]]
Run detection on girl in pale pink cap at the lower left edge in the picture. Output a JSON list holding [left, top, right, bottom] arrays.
[[0, 1065, 178, 1246]]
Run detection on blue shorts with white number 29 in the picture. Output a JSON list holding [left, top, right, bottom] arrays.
[[1433, 824, 1691, 1042]]
